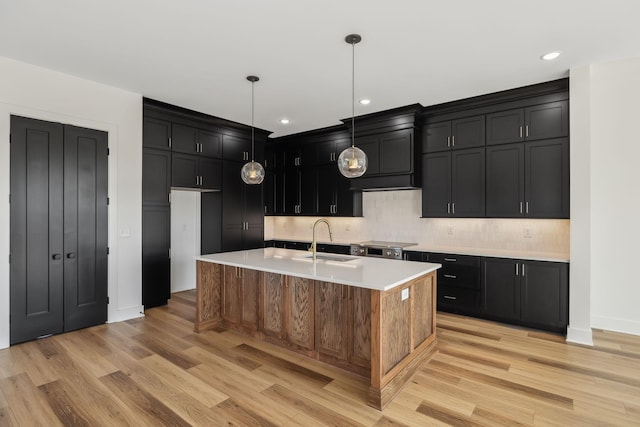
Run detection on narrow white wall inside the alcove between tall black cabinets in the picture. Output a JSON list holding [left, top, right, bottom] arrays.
[[171, 190, 200, 293]]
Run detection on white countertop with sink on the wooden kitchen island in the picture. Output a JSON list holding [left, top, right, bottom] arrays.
[[196, 248, 441, 291]]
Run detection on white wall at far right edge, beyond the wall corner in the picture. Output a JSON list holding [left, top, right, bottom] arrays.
[[584, 58, 640, 335]]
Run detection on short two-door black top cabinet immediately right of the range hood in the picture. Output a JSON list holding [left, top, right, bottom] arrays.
[[422, 115, 485, 153]]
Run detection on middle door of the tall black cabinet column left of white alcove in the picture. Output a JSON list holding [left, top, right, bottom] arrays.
[[142, 148, 171, 206]]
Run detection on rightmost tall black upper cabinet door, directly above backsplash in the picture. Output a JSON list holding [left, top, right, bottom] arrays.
[[524, 138, 569, 218]]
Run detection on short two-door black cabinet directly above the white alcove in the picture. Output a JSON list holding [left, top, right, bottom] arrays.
[[171, 153, 222, 190]]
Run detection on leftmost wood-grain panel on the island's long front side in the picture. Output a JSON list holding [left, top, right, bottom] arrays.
[[195, 261, 223, 331]]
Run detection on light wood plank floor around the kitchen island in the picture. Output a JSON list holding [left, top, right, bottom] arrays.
[[0, 291, 640, 426]]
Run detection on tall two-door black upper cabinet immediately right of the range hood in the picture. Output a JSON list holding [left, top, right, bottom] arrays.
[[422, 147, 485, 221]]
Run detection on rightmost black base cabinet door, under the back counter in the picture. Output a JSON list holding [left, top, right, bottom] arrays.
[[521, 261, 569, 328]]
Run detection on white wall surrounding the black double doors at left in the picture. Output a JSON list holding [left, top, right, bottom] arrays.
[[0, 57, 143, 348]]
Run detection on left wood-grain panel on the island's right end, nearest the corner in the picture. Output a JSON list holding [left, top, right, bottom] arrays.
[[380, 290, 412, 374]]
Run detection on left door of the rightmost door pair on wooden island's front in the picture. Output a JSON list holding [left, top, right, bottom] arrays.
[[316, 282, 349, 360]]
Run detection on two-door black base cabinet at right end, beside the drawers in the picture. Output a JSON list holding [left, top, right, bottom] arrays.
[[482, 258, 569, 332]]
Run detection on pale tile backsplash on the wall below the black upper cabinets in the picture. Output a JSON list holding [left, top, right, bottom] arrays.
[[265, 189, 570, 259]]
